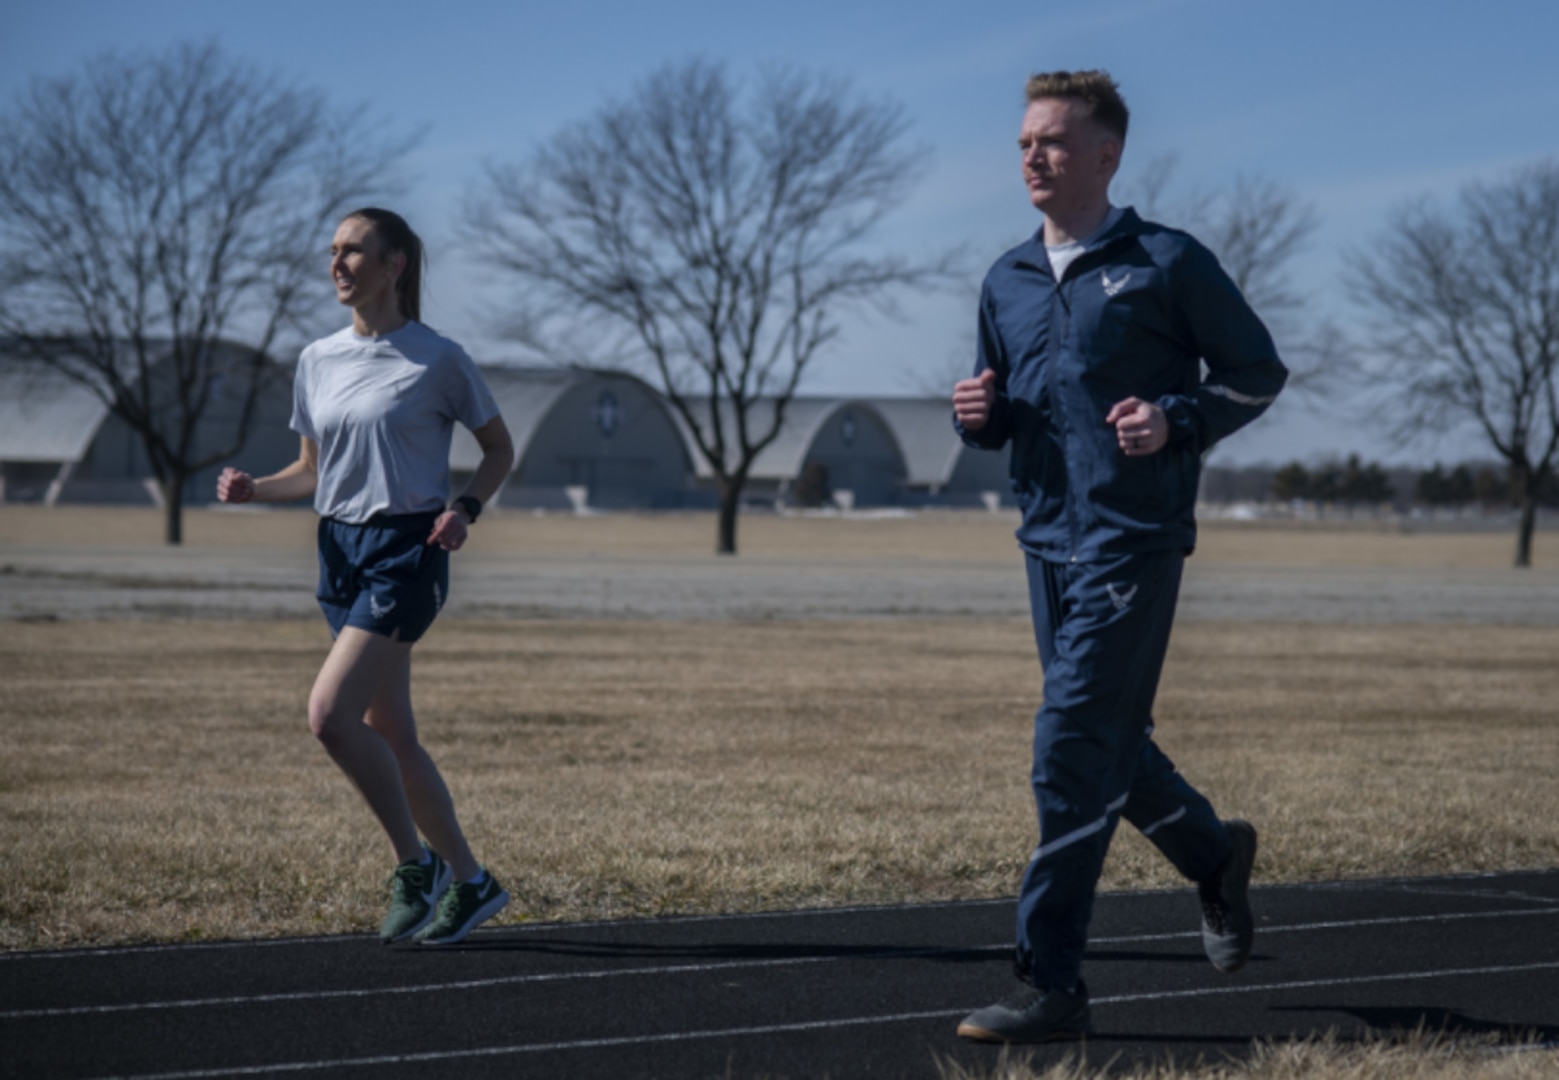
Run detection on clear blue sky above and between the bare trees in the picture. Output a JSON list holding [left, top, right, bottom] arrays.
[[0, 0, 1559, 464]]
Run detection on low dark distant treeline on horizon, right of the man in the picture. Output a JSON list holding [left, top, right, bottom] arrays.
[[1202, 454, 1559, 510]]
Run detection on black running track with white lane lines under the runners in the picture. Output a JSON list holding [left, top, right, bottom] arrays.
[[0, 871, 1559, 1080]]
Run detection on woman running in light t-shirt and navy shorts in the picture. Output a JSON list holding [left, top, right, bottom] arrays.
[[217, 207, 514, 944]]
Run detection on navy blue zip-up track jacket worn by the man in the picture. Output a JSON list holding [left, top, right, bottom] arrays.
[[954, 209, 1288, 563]]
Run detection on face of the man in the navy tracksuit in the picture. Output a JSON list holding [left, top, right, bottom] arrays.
[[1018, 98, 1121, 217]]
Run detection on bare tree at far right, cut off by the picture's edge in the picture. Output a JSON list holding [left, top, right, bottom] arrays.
[[1349, 161, 1559, 567]]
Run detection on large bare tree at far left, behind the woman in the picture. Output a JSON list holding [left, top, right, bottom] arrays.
[[0, 45, 408, 544]]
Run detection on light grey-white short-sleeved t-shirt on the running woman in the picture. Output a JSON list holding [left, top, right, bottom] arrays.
[[292, 323, 497, 524]]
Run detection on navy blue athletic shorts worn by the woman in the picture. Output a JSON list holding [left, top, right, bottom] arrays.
[[318, 513, 449, 642]]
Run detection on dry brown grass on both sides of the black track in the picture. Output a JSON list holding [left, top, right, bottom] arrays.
[[0, 508, 1559, 1080]]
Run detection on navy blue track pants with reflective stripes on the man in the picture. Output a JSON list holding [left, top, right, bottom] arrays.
[[1015, 552, 1230, 990]]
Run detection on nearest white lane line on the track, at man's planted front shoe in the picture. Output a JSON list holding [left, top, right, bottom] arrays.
[[76, 960, 1559, 1080]]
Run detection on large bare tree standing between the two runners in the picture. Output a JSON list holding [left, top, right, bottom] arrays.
[[465, 61, 945, 555]]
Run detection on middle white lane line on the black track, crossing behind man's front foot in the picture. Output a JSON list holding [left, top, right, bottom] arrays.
[[0, 907, 1559, 1021]]
